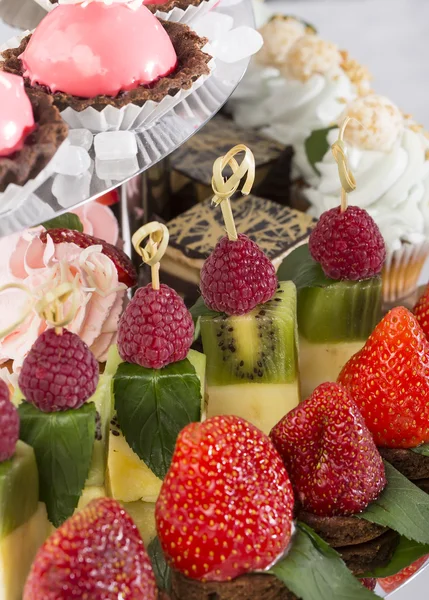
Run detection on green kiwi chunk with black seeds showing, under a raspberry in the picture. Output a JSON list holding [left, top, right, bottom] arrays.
[[201, 281, 298, 386]]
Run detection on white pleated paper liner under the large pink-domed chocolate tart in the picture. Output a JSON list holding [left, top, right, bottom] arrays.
[[0, 31, 216, 133]]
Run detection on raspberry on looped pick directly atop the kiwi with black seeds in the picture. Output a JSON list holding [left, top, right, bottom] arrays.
[[200, 233, 277, 315]]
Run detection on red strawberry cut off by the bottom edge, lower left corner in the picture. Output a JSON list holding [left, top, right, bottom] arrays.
[[23, 498, 157, 600]]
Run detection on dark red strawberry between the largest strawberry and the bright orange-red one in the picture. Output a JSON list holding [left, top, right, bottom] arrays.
[[270, 383, 386, 517]]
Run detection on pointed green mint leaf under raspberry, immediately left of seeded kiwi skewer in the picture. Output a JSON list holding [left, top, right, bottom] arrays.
[[113, 359, 201, 479]]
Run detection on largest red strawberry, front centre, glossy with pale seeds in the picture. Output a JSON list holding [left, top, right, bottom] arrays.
[[155, 416, 294, 581]]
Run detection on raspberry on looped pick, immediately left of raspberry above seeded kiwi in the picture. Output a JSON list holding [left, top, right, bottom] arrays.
[[118, 284, 194, 369]]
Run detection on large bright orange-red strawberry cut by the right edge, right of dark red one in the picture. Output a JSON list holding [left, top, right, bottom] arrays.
[[338, 306, 429, 448]]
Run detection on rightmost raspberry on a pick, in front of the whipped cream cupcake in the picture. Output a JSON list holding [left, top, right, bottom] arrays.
[[308, 206, 386, 281]]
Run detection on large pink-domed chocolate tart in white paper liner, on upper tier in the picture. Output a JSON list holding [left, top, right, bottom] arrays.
[[2, 2, 211, 131]]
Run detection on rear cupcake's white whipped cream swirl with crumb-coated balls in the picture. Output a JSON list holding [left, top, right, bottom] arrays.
[[232, 23, 370, 197]]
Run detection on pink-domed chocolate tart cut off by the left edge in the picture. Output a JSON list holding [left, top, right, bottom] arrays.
[[0, 73, 68, 193]]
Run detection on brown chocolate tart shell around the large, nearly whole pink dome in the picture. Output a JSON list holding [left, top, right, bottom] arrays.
[[0, 19, 212, 112]]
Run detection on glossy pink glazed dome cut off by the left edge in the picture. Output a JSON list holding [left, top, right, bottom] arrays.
[[0, 72, 34, 156]]
